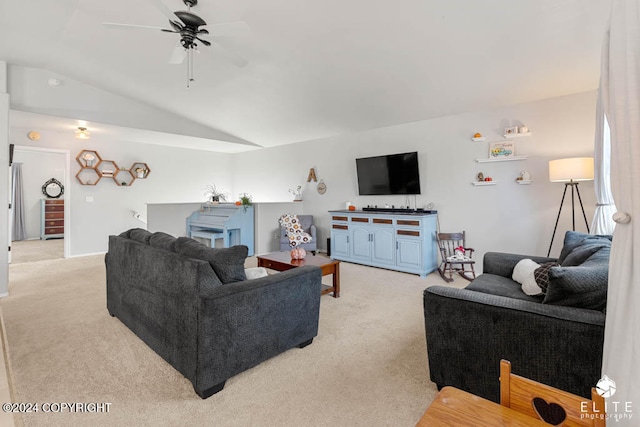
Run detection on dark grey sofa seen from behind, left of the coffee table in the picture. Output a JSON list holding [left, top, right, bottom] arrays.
[[105, 229, 321, 399]]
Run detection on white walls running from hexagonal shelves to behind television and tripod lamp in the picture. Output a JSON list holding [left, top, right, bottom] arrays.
[[10, 92, 596, 259]]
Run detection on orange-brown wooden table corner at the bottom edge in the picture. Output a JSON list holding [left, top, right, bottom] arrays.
[[416, 387, 549, 427]]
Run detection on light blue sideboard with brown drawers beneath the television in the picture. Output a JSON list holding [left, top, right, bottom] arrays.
[[329, 210, 437, 277]]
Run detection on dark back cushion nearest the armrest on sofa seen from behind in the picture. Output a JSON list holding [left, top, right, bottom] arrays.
[[175, 237, 249, 284]]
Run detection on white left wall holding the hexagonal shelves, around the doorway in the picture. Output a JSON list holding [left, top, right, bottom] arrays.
[[9, 130, 232, 256]]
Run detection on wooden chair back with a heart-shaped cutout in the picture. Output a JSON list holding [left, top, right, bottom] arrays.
[[500, 360, 606, 427]]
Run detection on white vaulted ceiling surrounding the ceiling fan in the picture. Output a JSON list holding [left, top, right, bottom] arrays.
[[0, 0, 611, 152]]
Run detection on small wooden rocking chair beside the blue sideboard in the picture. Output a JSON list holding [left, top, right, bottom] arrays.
[[436, 231, 476, 282]]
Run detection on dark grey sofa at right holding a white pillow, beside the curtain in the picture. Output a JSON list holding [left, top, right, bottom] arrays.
[[423, 231, 611, 402]]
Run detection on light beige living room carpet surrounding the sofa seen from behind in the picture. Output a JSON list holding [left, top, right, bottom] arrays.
[[0, 256, 467, 427]]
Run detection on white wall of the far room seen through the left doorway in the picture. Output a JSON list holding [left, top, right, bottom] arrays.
[[13, 147, 67, 239]]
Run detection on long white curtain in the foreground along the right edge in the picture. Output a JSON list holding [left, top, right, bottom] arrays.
[[600, 0, 640, 426]]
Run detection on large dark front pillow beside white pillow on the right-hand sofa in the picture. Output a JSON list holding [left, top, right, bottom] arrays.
[[543, 247, 610, 310]]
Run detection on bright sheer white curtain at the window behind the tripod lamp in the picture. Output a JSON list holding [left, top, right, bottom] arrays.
[[590, 93, 616, 234]]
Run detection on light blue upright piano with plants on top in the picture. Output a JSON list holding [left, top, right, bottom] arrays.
[[187, 203, 254, 256]]
